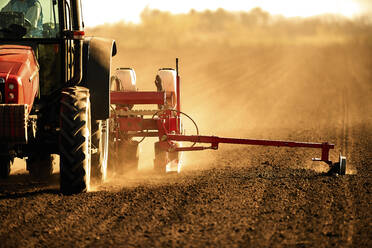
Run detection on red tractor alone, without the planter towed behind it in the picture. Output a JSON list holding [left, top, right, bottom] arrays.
[[0, 0, 116, 194]]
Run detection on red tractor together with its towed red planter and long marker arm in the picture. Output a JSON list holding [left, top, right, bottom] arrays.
[[0, 0, 346, 194]]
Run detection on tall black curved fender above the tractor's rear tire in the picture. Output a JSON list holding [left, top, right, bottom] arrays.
[[81, 37, 116, 120]]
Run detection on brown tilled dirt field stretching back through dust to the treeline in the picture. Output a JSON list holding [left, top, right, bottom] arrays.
[[0, 44, 372, 247]]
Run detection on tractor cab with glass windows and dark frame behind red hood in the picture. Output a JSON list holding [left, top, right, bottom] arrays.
[[0, 0, 83, 97]]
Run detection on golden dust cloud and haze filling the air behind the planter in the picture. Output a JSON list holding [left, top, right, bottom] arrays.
[[10, 9, 372, 182]]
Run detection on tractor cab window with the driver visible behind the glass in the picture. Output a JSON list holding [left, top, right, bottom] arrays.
[[0, 0, 60, 39]]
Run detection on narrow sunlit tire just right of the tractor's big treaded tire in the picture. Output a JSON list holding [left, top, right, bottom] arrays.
[[91, 120, 109, 183]]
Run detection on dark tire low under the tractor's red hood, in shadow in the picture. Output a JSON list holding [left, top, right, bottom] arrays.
[[26, 154, 55, 180]]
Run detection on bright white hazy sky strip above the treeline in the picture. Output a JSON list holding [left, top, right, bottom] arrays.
[[82, 0, 372, 26]]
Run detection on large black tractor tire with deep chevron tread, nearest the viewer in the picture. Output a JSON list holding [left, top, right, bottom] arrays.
[[59, 87, 91, 194]]
